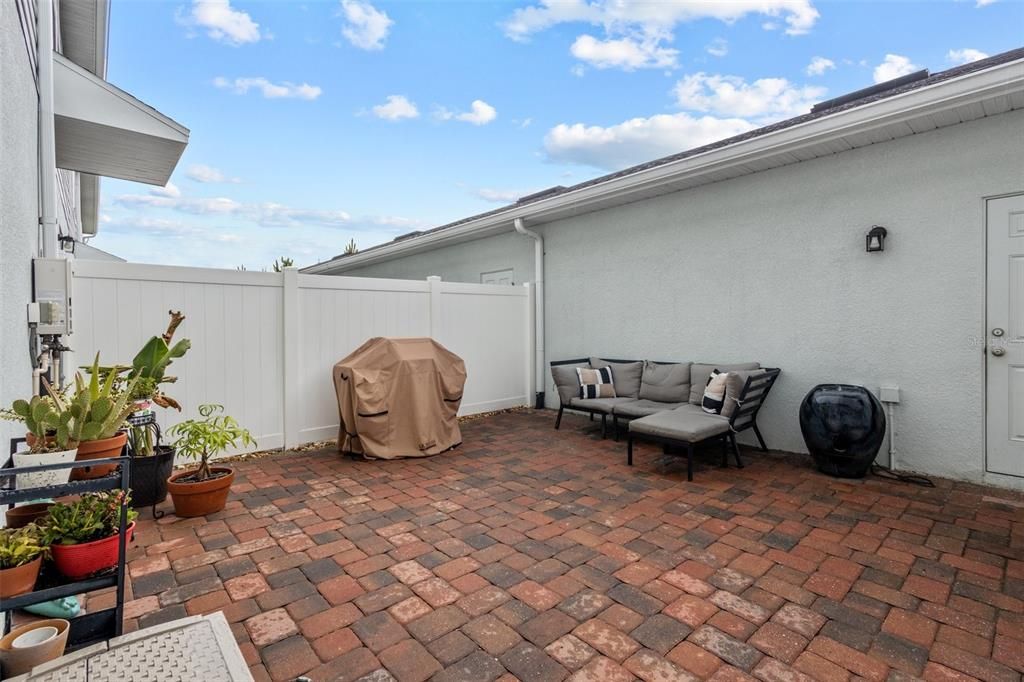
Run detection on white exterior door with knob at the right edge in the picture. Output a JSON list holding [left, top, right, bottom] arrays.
[[986, 195, 1024, 476]]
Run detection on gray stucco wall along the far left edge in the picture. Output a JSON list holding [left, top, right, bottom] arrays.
[[0, 2, 39, 456]]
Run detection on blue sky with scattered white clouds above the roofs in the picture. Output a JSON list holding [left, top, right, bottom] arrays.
[[92, 0, 1024, 269]]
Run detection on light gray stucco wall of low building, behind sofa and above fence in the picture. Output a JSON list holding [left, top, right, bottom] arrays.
[[323, 112, 1024, 487]]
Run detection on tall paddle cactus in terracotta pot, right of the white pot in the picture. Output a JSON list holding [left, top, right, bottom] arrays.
[[67, 353, 138, 480]]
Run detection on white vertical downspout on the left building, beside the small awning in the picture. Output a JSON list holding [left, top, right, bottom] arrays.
[[36, 0, 59, 258]]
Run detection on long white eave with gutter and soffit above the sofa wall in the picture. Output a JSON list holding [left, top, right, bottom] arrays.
[[303, 54, 1024, 273]]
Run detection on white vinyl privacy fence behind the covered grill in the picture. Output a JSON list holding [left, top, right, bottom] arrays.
[[70, 260, 534, 450]]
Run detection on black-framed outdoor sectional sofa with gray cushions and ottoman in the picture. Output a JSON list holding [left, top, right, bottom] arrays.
[[551, 357, 780, 480]]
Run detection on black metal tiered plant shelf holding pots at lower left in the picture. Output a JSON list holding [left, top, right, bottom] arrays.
[[0, 438, 131, 651]]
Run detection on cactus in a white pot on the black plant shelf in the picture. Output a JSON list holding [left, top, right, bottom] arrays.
[[0, 384, 78, 489]]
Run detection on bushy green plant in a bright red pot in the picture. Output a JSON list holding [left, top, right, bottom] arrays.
[[40, 491, 138, 580]]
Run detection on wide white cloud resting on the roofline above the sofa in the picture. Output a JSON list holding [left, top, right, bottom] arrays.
[[544, 113, 754, 170]]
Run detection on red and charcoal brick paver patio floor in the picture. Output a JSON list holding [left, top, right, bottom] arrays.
[[108, 412, 1024, 682]]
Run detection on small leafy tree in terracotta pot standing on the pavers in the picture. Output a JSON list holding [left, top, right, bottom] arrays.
[[167, 404, 256, 517]]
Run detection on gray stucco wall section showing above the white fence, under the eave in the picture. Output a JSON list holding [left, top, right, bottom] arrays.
[[343, 227, 534, 285]]
